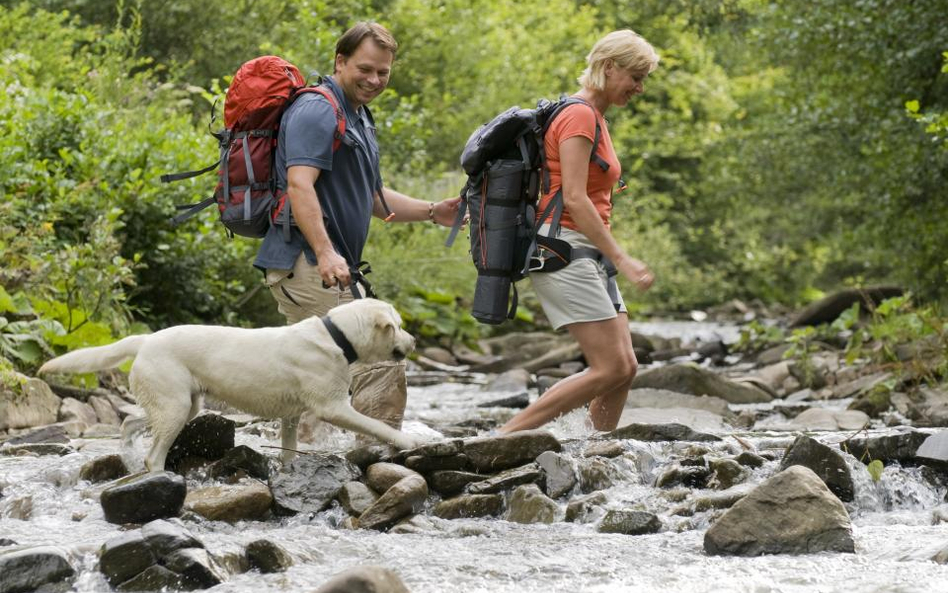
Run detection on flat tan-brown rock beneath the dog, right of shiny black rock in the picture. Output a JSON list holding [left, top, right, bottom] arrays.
[[184, 478, 273, 523]]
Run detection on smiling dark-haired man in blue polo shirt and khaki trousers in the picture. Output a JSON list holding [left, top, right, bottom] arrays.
[[254, 22, 460, 438]]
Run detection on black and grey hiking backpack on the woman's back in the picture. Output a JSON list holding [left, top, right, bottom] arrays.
[[445, 97, 609, 325]]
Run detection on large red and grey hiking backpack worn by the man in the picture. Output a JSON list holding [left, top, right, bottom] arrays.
[[161, 56, 346, 238]]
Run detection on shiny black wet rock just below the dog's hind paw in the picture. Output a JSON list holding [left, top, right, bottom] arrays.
[[100, 472, 187, 523]]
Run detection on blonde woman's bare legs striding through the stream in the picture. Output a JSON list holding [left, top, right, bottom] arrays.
[[500, 313, 638, 432]]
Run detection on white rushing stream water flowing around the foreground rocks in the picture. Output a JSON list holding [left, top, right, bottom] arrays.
[[0, 324, 948, 593]]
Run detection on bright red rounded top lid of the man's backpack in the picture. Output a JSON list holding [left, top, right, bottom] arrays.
[[224, 56, 306, 130]]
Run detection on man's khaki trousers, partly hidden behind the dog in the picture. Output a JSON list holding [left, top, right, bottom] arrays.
[[266, 253, 408, 429]]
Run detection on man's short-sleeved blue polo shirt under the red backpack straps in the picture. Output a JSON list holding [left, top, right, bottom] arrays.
[[253, 77, 382, 270]]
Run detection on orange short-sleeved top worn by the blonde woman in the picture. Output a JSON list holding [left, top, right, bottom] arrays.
[[537, 104, 622, 231]]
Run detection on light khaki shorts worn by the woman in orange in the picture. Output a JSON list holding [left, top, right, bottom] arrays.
[[530, 225, 626, 329]]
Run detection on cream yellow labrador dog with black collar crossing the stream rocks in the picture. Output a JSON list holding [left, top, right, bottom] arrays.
[[39, 299, 420, 472]]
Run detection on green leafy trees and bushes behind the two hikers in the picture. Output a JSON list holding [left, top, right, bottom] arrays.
[[0, 0, 948, 383]]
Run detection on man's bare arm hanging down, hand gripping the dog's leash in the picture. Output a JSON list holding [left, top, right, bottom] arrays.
[[286, 165, 350, 286]]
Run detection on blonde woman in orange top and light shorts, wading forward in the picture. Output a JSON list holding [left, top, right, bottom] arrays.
[[500, 30, 658, 433]]
